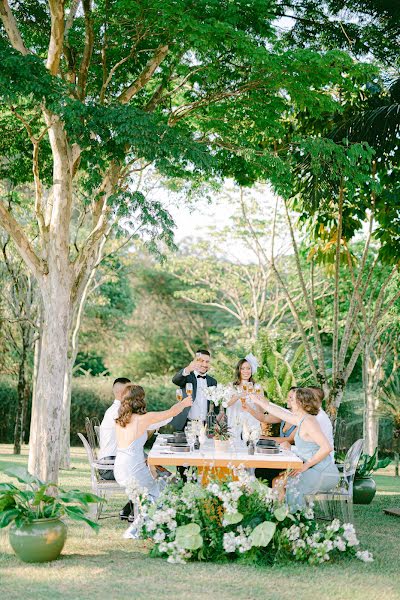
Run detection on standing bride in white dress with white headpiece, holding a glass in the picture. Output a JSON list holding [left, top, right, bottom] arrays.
[[226, 355, 263, 430]]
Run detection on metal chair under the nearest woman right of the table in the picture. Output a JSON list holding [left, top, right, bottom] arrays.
[[307, 439, 364, 523]]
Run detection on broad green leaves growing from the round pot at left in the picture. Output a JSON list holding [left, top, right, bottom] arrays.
[[0, 467, 102, 531]]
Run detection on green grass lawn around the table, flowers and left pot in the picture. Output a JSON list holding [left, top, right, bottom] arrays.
[[0, 445, 400, 600]]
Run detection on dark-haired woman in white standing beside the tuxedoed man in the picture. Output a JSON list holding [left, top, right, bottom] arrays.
[[226, 358, 263, 429]]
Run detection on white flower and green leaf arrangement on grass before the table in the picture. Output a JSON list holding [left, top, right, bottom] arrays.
[[127, 470, 373, 564]]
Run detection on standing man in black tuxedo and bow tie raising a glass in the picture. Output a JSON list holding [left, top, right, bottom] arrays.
[[172, 349, 217, 431]]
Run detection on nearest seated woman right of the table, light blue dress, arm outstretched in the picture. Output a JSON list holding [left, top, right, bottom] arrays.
[[252, 388, 339, 512]]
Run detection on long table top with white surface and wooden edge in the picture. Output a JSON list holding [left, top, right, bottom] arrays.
[[147, 435, 303, 469]]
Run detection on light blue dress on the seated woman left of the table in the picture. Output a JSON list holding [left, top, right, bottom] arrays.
[[114, 431, 165, 500]]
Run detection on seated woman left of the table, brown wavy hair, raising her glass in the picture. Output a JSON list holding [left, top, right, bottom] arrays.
[[114, 384, 192, 500]]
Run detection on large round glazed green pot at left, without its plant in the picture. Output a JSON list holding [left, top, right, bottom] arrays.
[[10, 519, 67, 562]]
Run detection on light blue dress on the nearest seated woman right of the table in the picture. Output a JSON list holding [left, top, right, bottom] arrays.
[[286, 417, 340, 512]]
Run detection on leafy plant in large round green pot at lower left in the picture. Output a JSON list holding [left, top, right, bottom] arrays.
[[0, 467, 101, 562]]
